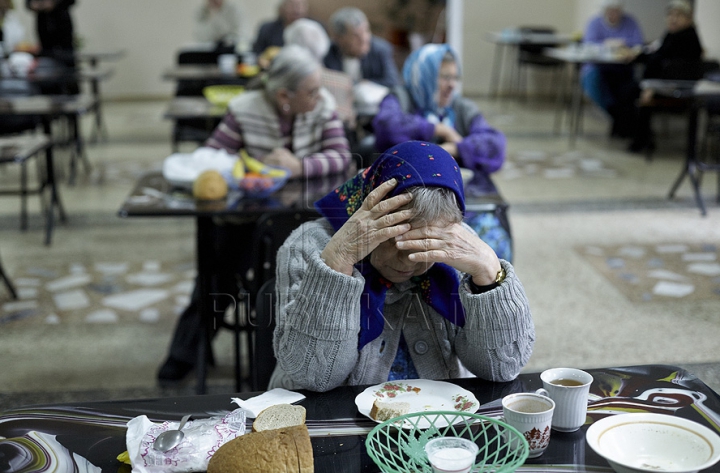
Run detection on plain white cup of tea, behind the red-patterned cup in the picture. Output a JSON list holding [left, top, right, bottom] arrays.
[[540, 368, 593, 432]]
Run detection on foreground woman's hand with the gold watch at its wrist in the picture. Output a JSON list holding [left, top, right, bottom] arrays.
[[395, 223, 500, 286]]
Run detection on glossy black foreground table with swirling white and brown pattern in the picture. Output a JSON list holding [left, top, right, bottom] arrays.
[[0, 364, 720, 473]]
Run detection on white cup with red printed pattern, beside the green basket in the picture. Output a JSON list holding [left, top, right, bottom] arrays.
[[503, 393, 555, 458]]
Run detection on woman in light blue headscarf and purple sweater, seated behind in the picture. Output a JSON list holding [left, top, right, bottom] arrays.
[[373, 44, 512, 261]]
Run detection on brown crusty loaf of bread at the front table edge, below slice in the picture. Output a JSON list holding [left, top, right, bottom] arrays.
[[207, 425, 315, 473]]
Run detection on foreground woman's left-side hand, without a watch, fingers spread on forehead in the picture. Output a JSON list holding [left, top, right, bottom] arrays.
[[320, 179, 412, 276]]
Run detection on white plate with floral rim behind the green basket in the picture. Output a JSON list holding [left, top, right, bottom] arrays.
[[355, 379, 480, 428]]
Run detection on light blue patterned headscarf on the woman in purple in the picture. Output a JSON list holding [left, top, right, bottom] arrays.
[[403, 44, 460, 126]]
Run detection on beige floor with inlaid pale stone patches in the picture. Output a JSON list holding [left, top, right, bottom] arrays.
[[0, 96, 720, 409]]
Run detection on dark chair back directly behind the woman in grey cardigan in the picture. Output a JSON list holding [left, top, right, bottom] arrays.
[[251, 277, 277, 391]]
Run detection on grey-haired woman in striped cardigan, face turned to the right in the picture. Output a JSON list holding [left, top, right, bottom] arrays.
[[205, 46, 350, 177]]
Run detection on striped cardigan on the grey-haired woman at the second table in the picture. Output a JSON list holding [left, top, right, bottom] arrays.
[[205, 89, 350, 177]]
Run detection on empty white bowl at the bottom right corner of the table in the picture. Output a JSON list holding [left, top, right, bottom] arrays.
[[585, 413, 720, 473]]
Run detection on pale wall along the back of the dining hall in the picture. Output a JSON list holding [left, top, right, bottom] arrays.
[[8, 0, 720, 98]]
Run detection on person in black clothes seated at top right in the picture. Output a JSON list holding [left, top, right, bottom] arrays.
[[628, 0, 703, 153]]
